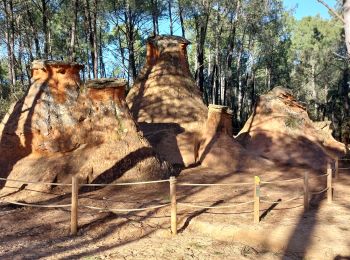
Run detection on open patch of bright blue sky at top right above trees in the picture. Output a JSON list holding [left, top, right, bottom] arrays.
[[283, 0, 337, 20]]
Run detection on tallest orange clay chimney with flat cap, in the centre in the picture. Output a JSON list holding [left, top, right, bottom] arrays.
[[126, 36, 208, 166]]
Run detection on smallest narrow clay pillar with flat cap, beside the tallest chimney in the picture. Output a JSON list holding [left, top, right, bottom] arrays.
[[199, 105, 273, 172]]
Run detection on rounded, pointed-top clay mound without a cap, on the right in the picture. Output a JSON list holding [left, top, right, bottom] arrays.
[[237, 87, 342, 169]]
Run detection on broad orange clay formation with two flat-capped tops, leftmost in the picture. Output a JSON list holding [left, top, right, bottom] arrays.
[[0, 61, 170, 195]]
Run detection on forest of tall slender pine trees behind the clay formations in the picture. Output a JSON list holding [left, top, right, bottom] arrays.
[[0, 0, 350, 139]]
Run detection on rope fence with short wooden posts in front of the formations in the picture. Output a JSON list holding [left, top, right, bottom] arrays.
[[0, 159, 342, 235]]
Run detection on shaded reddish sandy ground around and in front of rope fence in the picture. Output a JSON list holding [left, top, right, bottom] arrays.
[[0, 164, 350, 259]]
